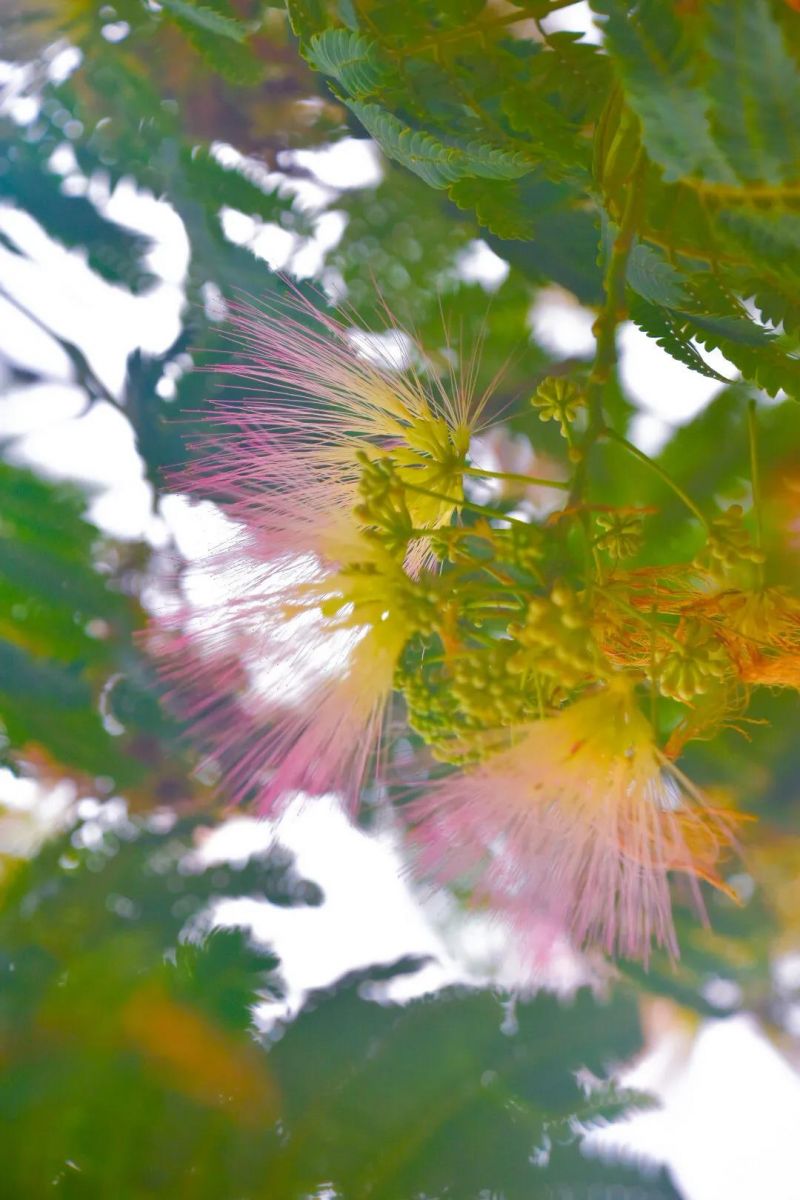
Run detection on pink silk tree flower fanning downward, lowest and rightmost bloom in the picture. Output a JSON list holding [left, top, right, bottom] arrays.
[[409, 684, 732, 961]]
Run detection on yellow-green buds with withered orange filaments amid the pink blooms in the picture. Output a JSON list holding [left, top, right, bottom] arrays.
[[343, 408, 786, 764]]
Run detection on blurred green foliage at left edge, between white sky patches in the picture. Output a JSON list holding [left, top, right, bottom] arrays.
[[0, 463, 191, 806]]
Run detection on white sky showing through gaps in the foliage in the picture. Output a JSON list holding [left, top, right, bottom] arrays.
[[0, 96, 800, 1200]]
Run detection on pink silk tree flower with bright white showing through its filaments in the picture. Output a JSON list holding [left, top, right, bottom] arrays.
[[148, 535, 422, 816]]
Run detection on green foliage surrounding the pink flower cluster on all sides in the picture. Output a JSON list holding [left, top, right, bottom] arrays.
[[0, 0, 800, 1200]]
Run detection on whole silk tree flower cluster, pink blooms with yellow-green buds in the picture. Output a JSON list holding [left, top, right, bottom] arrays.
[[154, 295, 800, 960]]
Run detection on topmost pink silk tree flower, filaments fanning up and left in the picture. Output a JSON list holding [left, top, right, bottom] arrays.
[[184, 287, 494, 565]]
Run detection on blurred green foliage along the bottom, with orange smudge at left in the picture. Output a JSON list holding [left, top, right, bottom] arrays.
[[0, 805, 675, 1200]]
